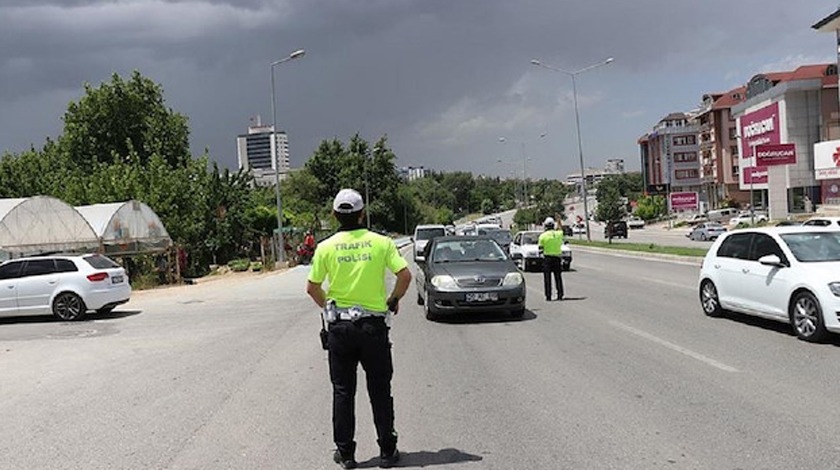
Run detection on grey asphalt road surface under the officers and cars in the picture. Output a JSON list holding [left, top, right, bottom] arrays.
[[0, 251, 840, 470]]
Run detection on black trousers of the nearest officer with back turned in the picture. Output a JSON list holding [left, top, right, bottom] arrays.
[[329, 317, 397, 455]]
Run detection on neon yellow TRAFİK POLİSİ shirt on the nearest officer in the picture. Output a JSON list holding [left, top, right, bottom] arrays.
[[309, 229, 408, 312]]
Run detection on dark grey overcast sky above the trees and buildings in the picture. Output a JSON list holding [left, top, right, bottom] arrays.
[[0, 0, 838, 180]]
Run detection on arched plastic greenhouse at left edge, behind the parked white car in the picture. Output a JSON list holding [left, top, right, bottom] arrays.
[[0, 196, 99, 259]]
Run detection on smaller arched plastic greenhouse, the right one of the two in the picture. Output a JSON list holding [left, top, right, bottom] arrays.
[[75, 200, 172, 256]]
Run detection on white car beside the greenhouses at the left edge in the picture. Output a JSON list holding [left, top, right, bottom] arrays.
[[0, 254, 131, 321]]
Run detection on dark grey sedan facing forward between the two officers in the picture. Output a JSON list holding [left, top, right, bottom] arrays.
[[417, 236, 525, 320]]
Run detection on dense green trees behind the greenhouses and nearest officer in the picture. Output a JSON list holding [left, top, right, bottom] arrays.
[[0, 71, 568, 276]]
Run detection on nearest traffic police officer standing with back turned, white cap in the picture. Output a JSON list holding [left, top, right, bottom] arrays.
[[306, 189, 411, 468]]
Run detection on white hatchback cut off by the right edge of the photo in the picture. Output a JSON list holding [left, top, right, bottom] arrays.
[[699, 226, 840, 342]]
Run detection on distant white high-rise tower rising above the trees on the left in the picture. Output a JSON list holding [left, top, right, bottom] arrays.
[[236, 116, 289, 186]]
